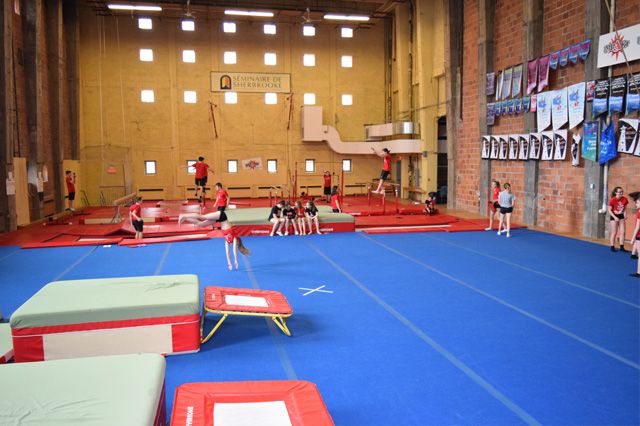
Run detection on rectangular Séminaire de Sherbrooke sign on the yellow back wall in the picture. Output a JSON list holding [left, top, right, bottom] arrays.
[[211, 71, 291, 93]]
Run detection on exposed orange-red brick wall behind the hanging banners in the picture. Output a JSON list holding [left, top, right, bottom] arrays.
[[456, 0, 640, 233]]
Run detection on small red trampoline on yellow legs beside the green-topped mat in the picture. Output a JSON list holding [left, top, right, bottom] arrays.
[[200, 286, 293, 343]]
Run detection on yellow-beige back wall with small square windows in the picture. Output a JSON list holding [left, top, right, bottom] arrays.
[[79, 9, 385, 203]]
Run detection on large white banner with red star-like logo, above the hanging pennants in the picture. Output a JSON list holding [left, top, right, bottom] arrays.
[[598, 24, 640, 68]]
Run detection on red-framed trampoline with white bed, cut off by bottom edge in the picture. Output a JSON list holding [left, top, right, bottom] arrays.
[[171, 380, 333, 426]]
